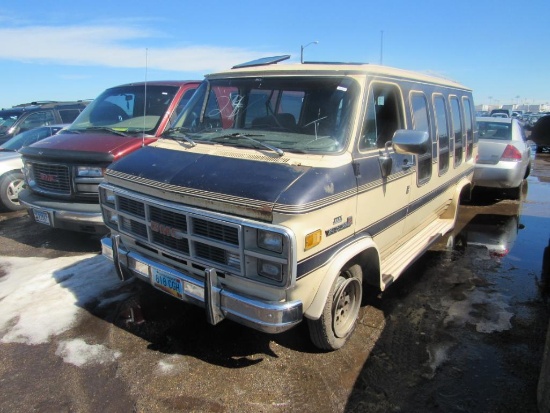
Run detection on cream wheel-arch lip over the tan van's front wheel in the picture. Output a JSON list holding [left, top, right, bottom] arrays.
[[304, 237, 380, 320]]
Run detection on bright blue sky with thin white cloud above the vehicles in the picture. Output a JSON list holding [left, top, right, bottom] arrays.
[[0, 0, 550, 107]]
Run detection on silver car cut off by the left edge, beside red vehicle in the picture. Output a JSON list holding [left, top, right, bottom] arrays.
[[0, 124, 69, 211]]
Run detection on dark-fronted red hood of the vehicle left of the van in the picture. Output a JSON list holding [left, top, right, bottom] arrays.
[[19, 132, 157, 163]]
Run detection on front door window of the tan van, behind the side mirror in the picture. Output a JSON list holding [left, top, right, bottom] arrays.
[[359, 83, 404, 150]]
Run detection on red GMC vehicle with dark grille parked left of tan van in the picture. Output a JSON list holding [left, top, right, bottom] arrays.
[[19, 81, 200, 233]]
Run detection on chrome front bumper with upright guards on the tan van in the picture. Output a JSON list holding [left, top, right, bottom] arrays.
[[101, 235, 303, 333]]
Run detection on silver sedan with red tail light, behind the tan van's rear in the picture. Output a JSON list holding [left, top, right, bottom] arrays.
[[473, 117, 531, 199]]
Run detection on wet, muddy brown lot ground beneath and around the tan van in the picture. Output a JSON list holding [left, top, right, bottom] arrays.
[[0, 155, 550, 413]]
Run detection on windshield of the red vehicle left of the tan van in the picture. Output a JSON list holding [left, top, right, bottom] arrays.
[[68, 84, 178, 136]]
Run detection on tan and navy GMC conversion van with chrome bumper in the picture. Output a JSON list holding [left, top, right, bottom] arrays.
[[100, 56, 477, 350]]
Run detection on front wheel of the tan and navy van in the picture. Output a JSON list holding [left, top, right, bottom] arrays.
[[307, 264, 363, 350]]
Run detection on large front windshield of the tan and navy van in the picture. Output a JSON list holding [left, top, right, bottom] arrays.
[[163, 76, 359, 153]]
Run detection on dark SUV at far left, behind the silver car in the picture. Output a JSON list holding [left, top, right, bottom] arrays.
[[0, 100, 90, 145]]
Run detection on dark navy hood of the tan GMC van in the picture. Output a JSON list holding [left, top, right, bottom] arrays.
[[106, 147, 356, 221]]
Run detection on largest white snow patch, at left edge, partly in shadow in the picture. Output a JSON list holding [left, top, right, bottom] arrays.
[[0, 254, 120, 344]]
